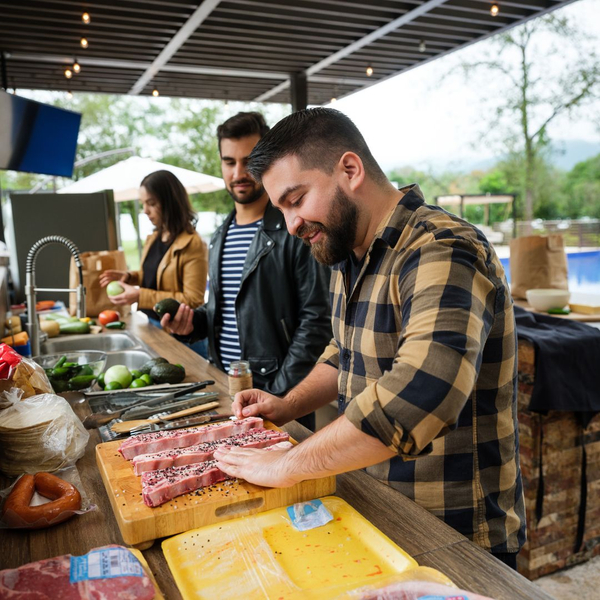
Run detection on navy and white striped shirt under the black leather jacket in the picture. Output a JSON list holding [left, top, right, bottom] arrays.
[[217, 218, 262, 370]]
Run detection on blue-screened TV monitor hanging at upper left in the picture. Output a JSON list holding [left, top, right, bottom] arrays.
[[0, 91, 81, 177]]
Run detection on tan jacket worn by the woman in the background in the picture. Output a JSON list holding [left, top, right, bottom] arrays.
[[127, 231, 208, 309]]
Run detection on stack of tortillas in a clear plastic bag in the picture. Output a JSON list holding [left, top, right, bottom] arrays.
[[0, 386, 90, 477]]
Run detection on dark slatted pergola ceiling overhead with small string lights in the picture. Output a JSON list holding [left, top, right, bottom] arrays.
[[0, 0, 569, 103]]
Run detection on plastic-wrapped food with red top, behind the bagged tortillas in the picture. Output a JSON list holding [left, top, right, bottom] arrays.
[[0, 344, 52, 410]]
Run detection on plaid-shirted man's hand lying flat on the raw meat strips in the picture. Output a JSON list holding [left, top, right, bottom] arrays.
[[215, 447, 302, 487]]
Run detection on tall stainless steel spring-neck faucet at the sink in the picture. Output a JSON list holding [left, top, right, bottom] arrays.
[[25, 235, 85, 356]]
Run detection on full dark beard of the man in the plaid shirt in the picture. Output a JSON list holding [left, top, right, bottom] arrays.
[[296, 187, 358, 266]]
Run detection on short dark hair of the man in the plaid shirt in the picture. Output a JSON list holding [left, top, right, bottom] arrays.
[[248, 108, 387, 183]]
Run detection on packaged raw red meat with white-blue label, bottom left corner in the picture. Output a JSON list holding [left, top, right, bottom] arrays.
[[0, 546, 156, 600]]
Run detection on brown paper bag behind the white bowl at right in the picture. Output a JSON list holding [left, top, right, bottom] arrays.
[[510, 233, 569, 298]]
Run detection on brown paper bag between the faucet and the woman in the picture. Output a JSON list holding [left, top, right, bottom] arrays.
[[69, 250, 131, 317]]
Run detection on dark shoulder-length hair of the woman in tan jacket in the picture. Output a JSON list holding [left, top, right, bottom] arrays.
[[140, 171, 198, 240]]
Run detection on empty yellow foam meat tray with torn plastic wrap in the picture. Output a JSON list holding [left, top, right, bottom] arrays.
[[162, 496, 452, 600]]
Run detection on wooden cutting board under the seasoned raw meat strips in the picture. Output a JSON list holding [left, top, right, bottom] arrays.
[[96, 421, 335, 550]]
